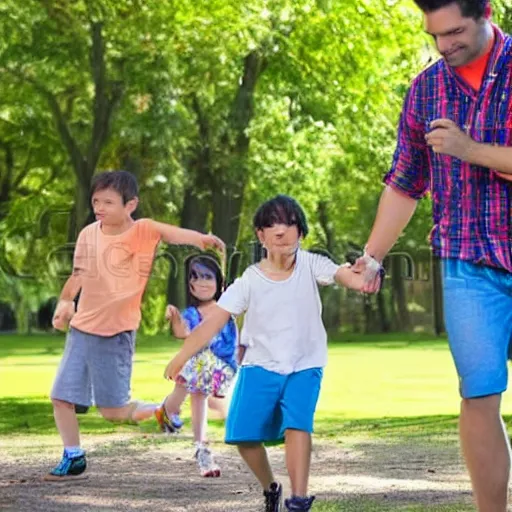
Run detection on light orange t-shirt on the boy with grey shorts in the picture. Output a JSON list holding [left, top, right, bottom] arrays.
[[70, 219, 161, 336]]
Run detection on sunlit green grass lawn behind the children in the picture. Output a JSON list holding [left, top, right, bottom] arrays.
[[0, 335, 512, 512]]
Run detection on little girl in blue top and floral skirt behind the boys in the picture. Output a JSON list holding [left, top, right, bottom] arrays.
[[155, 255, 243, 477]]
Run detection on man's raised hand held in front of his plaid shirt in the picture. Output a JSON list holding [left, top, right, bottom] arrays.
[[425, 119, 476, 162]]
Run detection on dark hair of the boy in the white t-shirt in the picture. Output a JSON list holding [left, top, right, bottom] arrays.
[[253, 194, 309, 238]]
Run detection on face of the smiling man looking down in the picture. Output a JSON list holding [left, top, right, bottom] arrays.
[[424, 2, 488, 67]]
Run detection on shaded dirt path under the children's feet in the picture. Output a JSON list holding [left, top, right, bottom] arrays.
[[0, 435, 470, 512]]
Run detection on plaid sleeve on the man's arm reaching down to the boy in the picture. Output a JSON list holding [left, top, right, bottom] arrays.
[[384, 83, 430, 199]]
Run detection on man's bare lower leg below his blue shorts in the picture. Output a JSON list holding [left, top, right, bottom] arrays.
[[459, 395, 510, 512]]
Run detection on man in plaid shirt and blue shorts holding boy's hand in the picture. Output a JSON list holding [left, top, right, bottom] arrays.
[[354, 0, 512, 512]]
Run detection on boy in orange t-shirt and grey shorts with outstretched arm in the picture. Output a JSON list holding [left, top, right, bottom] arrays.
[[45, 171, 224, 481]]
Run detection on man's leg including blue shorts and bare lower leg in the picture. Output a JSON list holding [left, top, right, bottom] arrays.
[[442, 260, 512, 512]]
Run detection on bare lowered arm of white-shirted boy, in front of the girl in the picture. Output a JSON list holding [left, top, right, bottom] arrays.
[[164, 306, 231, 379]]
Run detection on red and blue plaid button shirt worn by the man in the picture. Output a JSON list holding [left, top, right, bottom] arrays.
[[384, 27, 512, 272]]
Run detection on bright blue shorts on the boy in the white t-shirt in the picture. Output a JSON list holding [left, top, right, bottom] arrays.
[[226, 366, 323, 444]]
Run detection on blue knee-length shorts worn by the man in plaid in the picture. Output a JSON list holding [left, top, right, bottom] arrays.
[[442, 259, 512, 398]]
